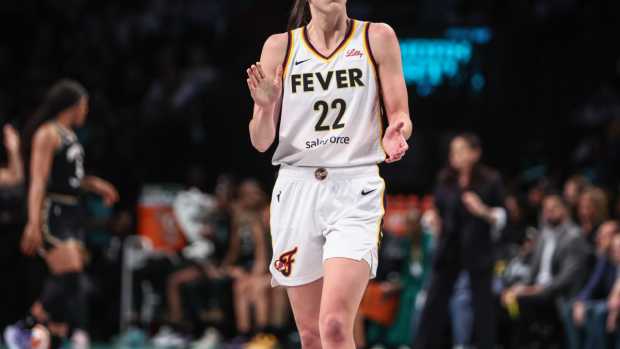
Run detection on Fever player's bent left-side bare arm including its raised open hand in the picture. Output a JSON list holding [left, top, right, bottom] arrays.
[[247, 33, 288, 152]]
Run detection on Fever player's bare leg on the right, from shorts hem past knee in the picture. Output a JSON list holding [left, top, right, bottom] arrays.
[[319, 258, 370, 349]]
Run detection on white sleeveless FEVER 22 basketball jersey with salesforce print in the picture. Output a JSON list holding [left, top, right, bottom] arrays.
[[273, 20, 385, 167]]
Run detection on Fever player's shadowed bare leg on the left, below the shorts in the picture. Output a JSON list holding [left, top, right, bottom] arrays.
[[286, 279, 323, 349]]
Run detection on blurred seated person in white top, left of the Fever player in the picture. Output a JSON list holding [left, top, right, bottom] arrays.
[[127, 171, 232, 347]]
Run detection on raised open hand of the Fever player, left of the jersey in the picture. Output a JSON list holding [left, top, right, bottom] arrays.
[[246, 62, 282, 108]]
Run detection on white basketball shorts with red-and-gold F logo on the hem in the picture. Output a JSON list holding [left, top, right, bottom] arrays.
[[269, 165, 385, 286]]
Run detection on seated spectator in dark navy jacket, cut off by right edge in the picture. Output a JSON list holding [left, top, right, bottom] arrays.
[[563, 221, 620, 349]]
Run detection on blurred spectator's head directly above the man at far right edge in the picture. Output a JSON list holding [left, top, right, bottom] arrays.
[[577, 186, 609, 246]]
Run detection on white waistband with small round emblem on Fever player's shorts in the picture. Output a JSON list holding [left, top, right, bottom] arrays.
[[278, 165, 380, 181]]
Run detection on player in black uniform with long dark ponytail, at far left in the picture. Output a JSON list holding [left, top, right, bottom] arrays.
[[5, 80, 118, 349]]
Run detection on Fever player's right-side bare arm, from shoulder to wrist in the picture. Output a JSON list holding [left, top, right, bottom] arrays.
[[368, 23, 413, 139]]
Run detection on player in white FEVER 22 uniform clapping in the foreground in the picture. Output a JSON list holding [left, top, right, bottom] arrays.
[[247, 0, 412, 349]]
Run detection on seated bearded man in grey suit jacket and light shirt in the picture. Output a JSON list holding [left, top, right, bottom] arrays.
[[502, 195, 590, 348]]
